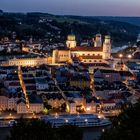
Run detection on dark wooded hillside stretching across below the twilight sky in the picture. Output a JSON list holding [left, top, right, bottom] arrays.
[[0, 12, 140, 43]]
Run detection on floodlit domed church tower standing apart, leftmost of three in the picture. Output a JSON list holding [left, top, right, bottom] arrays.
[[66, 35, 76, 49]]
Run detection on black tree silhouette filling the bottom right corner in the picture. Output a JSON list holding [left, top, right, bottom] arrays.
[[101, 101, 140, 140]]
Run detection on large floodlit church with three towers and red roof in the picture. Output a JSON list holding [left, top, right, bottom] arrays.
[[52, 34, 111, 63]]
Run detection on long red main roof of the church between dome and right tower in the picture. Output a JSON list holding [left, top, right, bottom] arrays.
[[71, 46, 103, 52]]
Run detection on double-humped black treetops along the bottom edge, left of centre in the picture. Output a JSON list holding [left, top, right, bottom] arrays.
[[7, 119, 83, 140]]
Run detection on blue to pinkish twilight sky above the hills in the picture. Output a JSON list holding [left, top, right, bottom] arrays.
[[0, 0, 140, 16]]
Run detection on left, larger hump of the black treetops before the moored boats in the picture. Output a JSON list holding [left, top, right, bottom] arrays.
[[8, 119, 54, 140]]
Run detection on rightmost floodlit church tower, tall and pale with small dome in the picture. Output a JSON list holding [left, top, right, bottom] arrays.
[[103, 35, 111, 59]]
